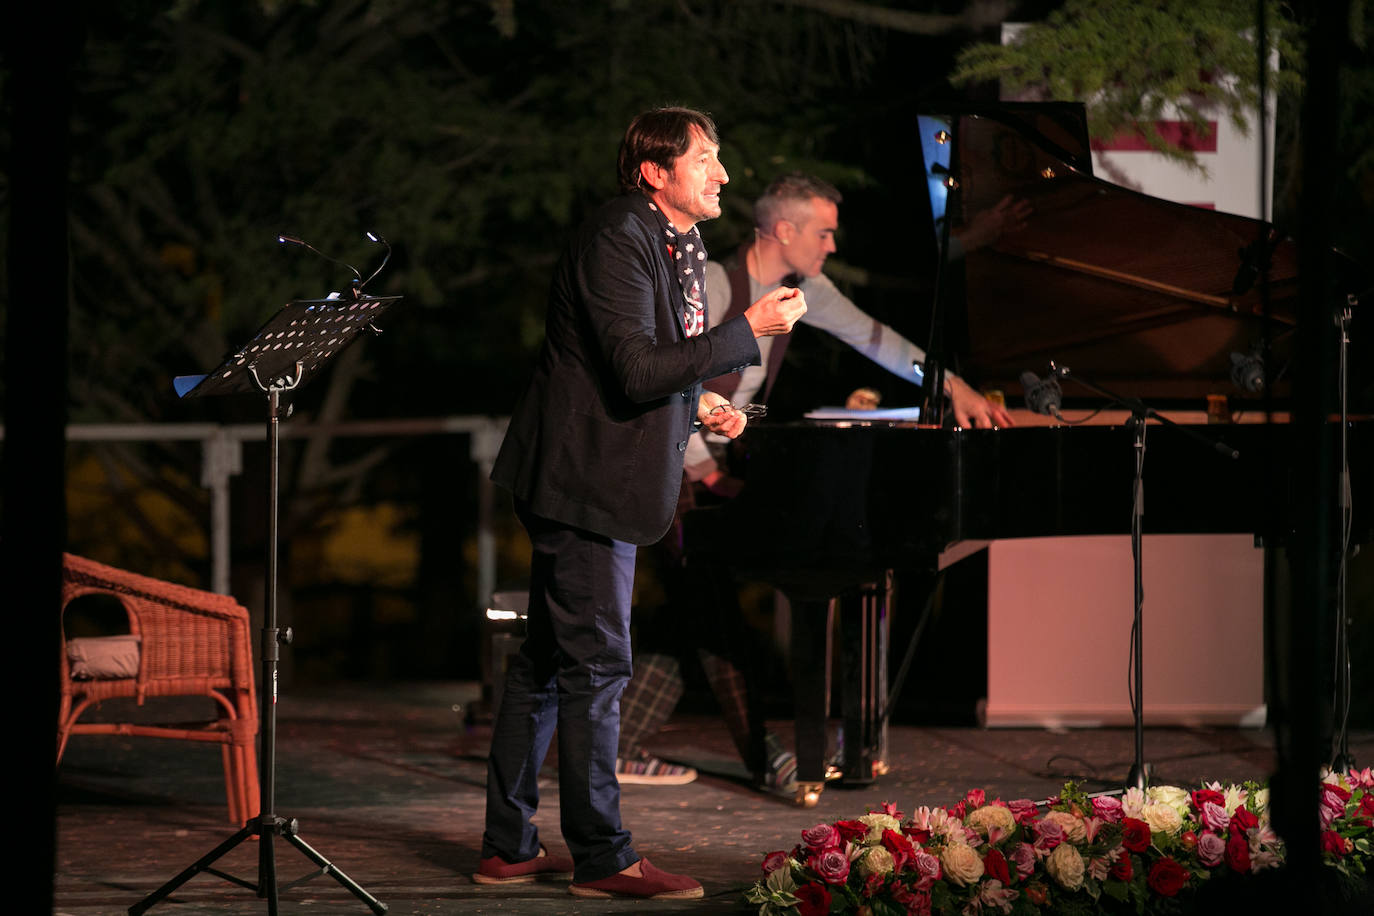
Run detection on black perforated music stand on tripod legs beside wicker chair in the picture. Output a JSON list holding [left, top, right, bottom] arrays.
[[129, 293, 401, 916]]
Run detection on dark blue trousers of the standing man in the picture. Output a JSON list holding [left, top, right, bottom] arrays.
[[482, 504, 639, 882]]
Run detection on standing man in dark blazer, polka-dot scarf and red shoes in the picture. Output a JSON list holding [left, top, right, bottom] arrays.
[[474, 108, 807, 897]]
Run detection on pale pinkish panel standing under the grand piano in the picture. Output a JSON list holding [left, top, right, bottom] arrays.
[[982, 534, 1265, 728]]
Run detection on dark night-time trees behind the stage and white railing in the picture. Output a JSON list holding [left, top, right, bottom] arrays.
[[0, 0, 1374, 906]]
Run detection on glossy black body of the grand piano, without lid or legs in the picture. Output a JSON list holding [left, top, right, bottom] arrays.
[[684, 422, 1374, 597]]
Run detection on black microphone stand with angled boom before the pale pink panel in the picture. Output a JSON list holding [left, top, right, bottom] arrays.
[[1050, 363, 1241, 790]]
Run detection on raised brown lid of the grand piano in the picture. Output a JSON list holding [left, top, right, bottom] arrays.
[[918, 103, 1297, 398]]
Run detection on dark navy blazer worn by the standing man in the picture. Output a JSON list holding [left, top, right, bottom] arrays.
[[492, 192, 758, 545]]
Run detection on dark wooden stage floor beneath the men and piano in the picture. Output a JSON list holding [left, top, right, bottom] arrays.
[[55, 684, 1374, 916]]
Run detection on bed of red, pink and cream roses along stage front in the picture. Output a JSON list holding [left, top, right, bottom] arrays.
[[745, 769, 1374, 916]]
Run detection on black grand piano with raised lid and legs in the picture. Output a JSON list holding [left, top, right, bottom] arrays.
[[684, 104, 1374, 803]]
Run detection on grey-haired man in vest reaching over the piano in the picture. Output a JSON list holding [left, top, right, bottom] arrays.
[[617, 173, 1028, 794]]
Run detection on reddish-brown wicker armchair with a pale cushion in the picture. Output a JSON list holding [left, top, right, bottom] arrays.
[[58, 553, 258, 824]]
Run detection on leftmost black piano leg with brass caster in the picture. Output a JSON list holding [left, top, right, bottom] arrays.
[[790, 600, 834, 808]]
